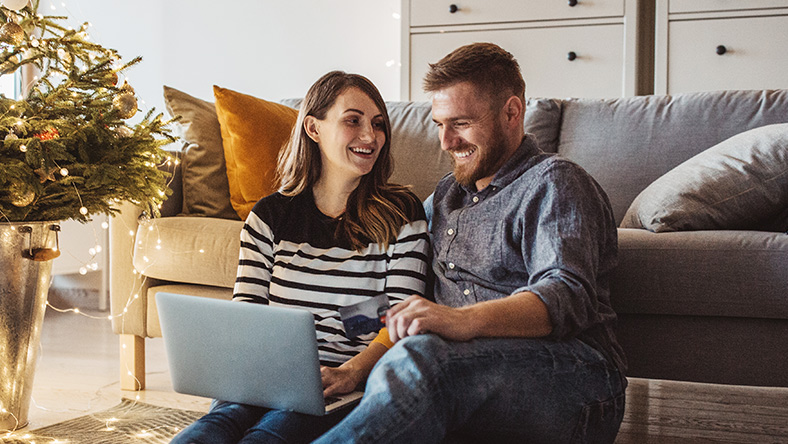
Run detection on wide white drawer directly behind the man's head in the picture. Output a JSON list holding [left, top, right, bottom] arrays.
[[410, 24, 624, 100]]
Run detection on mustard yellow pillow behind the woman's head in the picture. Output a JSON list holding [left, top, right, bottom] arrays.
[[213, 85, 298, 220]]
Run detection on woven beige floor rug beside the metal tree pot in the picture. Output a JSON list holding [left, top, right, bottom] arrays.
[[0, 399, 205, 444]]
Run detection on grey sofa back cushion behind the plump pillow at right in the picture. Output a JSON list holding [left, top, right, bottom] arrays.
[[558, 90, 788, 222]]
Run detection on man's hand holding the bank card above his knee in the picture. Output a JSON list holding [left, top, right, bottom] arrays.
[[386, 295, 476, 342]]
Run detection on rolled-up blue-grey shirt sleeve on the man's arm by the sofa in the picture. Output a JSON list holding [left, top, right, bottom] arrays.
[[514, 162, 616, 339]]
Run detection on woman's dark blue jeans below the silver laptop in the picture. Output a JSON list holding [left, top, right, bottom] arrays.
[[170, 401, 351, 444]]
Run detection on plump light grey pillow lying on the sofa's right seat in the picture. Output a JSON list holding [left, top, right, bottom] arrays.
[[621, 124, 788, 232]]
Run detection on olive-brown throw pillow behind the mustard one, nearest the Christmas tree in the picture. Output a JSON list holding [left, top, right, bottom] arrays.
[[164, 86, 238, 219]]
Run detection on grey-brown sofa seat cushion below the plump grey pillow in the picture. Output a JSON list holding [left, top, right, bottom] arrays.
[[610, 228, 788, 319]]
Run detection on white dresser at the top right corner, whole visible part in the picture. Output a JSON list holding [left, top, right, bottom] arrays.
[[654, 0, 788, 94]]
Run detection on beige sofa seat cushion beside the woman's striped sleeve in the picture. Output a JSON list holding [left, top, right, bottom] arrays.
[[134, 217, 244, 288]]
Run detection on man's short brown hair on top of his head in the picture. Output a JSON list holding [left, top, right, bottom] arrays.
[[424, 43, 525, 103]]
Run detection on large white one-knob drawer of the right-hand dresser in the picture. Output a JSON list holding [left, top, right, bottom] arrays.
[[667, 16, 788, 93]]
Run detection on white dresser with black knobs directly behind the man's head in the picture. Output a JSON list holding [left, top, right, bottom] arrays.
[[401, 0, 650, 100]]
